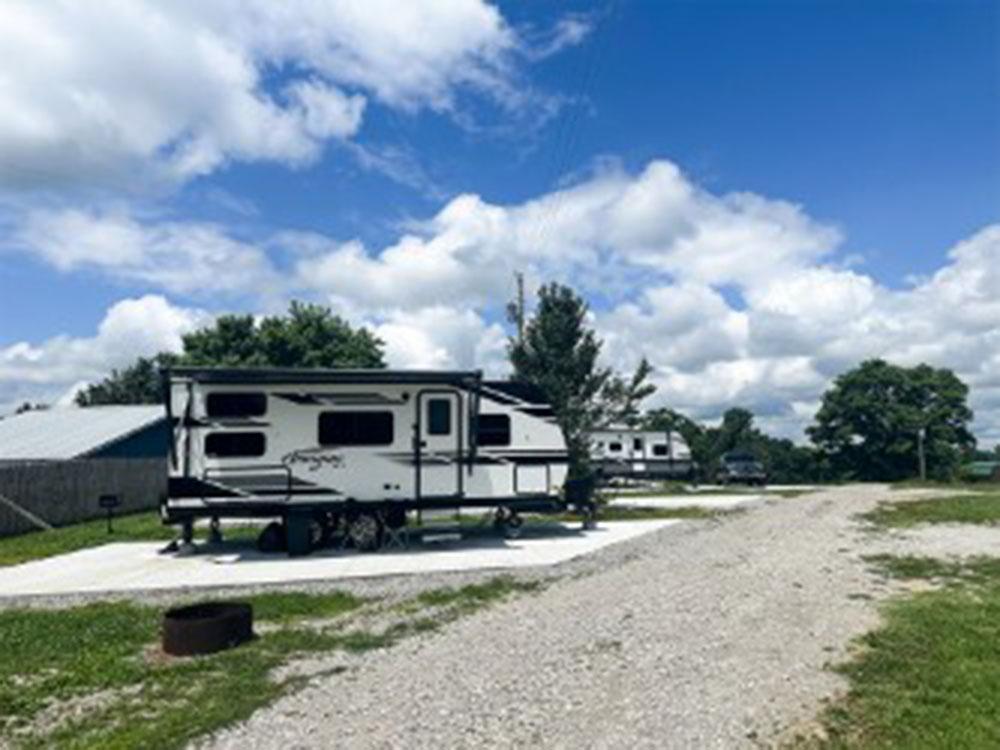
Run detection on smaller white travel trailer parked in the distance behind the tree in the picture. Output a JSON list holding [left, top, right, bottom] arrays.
[[590, 426, 694, 480]]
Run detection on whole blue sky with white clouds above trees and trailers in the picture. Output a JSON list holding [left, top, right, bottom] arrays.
[[0, 0, 1000, 437]]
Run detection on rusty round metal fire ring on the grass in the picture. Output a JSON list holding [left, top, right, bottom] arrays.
[[163, 602, 253, 656]]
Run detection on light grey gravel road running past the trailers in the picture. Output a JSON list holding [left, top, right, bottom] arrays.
[[203, 486, 920, 748]]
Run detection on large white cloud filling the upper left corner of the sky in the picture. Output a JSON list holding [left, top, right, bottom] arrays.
[[0, 0, 568, 189]]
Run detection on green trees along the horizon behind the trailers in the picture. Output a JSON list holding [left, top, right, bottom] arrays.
[[70, 283, 975, 482]]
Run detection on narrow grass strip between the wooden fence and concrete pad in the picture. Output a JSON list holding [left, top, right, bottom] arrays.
[[0, 512, 176, 566]]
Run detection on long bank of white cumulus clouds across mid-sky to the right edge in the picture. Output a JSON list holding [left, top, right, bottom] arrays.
[[5, 154, 1000, 442]]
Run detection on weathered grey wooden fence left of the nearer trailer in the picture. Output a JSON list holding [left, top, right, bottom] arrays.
[[0, 458, 167, 537]]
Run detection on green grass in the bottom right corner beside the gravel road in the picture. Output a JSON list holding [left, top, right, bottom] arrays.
[[803, 556, 1000, 750]]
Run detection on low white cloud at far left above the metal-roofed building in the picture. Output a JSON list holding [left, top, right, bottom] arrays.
[[0, 295, 210, 414]]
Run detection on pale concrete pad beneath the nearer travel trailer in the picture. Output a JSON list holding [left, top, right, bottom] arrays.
[[0, 519, 679, 598]]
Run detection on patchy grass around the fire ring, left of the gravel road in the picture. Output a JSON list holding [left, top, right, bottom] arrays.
[[0, 577, 537, 749]]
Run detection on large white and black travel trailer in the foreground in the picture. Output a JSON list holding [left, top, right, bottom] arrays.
[[162, 367, 568, 553]]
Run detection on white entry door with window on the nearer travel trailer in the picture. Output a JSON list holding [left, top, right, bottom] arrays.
[[417, 391, 464, 498]]
